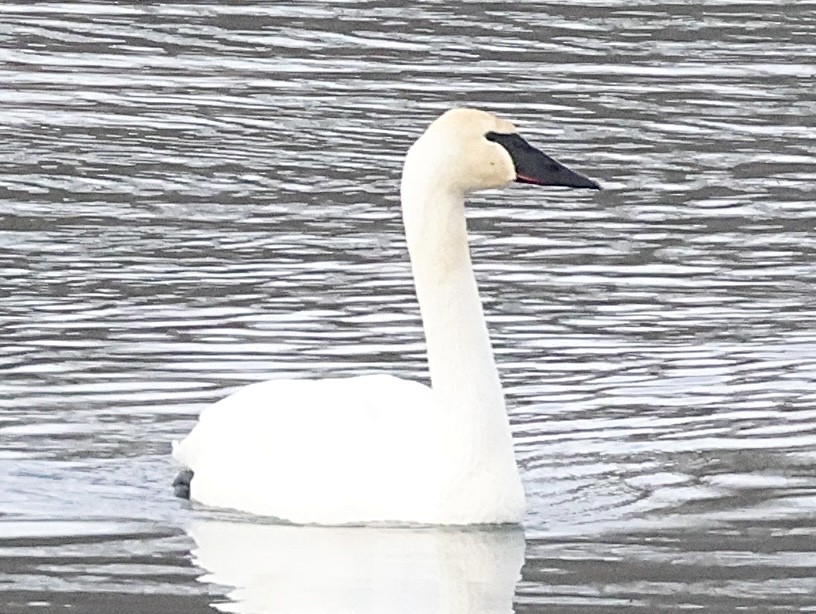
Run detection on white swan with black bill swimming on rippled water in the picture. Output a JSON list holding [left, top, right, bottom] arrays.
[[173, 108, 599, 525]]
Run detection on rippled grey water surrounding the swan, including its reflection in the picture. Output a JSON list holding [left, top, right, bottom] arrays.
[[0, 0, 816, 613]]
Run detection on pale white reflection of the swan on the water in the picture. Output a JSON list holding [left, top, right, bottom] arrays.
[[187, 519, 524, 614]]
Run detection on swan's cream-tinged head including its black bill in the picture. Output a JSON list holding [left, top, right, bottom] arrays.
[[403, 109, 600, 195]]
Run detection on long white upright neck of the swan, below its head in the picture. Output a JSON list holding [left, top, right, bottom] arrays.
[[402, 170, 515, 471]]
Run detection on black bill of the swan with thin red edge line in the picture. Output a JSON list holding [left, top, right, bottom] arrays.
[[485, 132, 601, 190]]
